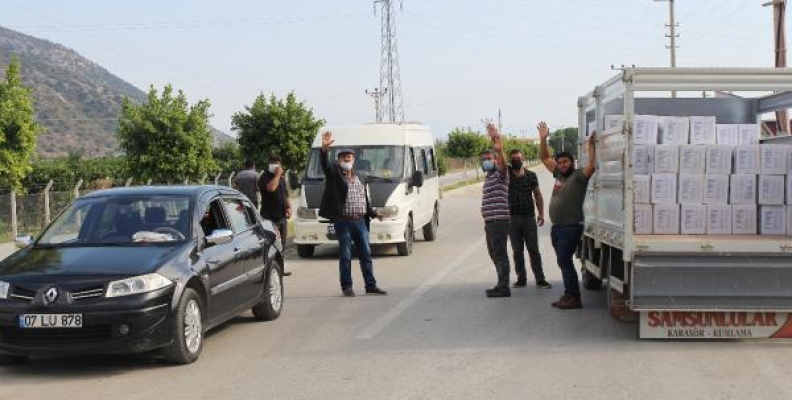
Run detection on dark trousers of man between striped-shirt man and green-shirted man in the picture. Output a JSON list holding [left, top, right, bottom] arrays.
[[509, 215, 545, 282]]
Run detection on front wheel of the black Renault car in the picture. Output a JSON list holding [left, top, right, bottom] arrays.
[[165, 288, 204, 364]]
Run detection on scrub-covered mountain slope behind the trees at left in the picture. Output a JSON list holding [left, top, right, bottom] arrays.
[[0, 27, 234, 157]]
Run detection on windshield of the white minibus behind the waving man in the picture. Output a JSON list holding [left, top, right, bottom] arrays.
[[306, 146, 404, 180]]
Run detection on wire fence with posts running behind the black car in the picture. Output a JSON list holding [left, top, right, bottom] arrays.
[[0, 172, 241, 243]]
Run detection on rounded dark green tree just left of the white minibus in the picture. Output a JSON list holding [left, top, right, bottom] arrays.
[[231, 92, 325, 171]]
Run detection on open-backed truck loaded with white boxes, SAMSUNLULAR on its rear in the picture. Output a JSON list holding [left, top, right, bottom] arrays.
[[578, 67, 792, 339]]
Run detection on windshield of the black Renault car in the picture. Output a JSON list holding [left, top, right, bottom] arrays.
[[36, 196, 191, 246]]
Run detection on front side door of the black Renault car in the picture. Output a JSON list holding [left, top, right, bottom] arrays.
[[201, 198, 245, 320]]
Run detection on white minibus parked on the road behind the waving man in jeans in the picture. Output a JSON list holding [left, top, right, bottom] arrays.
[[290, 123, 441, 258]]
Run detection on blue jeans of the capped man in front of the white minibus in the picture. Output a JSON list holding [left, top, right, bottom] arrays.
[[335, 219, 377, 289]]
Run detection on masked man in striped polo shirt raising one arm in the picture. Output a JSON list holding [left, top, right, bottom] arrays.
[[481, 122, 511, 297]]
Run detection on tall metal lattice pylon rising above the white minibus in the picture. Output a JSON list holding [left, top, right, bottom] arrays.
[[374, 0, 404, 123]]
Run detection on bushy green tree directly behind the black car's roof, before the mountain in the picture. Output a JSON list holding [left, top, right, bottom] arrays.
[[118, 85, 217, 182]]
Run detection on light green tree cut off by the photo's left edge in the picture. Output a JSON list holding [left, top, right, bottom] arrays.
[[0, 58, 39, 191]]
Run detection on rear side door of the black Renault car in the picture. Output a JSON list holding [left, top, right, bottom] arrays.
[[223, 197, 266, 302]]
